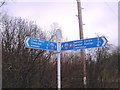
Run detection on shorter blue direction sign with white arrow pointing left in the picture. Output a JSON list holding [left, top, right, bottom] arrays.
[[24, 37, 57, 50]]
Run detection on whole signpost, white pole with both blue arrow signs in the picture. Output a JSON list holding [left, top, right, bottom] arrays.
[[24, 35, 107, 88]]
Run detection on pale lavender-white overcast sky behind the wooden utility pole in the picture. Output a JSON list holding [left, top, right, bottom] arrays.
[[4, 0, 118, 45]]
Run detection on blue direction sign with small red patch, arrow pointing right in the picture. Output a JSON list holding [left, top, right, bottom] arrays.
[[61, 36, 107, 50]]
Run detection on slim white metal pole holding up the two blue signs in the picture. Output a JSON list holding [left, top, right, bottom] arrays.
[[57, 42, 61, 90]]
